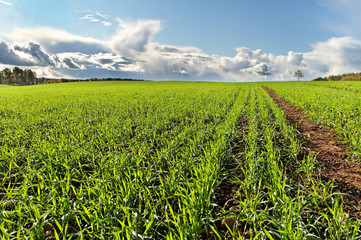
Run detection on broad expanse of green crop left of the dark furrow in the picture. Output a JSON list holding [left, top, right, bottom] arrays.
[[1, 81, 242, 239]]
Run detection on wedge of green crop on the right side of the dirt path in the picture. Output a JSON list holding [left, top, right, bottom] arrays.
[[262, 82, 361, 159]]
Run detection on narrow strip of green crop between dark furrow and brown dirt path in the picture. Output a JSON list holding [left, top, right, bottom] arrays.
[[217, 86, 360, 239]]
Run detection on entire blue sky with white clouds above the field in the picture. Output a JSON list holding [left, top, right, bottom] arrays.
[[0, 0, 361, 82]]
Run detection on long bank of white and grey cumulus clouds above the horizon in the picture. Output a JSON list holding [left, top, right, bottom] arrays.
[[0, 17, 361, 81]]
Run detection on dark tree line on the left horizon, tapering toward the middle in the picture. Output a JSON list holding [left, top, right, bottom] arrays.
[[0, 67, 145, 85]]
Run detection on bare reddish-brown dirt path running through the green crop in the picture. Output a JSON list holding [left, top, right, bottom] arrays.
[[263, 87, 361, 219]]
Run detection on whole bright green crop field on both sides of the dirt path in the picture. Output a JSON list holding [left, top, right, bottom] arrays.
[[0, 82, 361, 239]]
